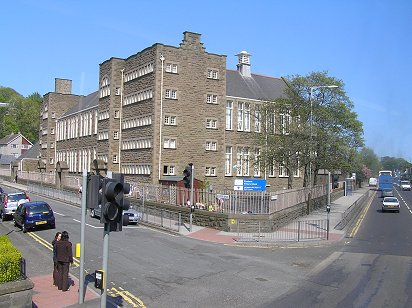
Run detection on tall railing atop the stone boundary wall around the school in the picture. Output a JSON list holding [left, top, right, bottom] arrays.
[[14, 171, 338, 214]]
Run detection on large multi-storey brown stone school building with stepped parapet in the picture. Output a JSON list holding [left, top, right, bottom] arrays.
[[39, 32, 303, 191]]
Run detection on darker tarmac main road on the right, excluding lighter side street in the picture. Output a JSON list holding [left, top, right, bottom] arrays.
[[265, 186, 412, 307]]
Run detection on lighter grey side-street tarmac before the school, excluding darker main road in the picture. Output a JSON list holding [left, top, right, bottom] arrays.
[[0, 186, 335, 308]]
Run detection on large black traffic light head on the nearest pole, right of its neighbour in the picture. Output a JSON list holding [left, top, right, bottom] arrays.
[[100, 174, 130, 231]]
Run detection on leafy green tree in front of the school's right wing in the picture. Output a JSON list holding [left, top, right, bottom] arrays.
[[256, 72, 363, 188]]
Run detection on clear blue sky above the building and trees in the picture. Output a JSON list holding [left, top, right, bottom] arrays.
[[0, 0, 412, 162]]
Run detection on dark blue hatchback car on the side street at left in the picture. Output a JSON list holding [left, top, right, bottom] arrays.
[[13, 201, 56, 233]]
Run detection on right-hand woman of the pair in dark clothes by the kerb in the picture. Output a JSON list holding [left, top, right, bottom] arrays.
[[56, 231, 73, 292]]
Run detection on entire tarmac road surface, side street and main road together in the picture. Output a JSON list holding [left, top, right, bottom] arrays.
[[0, 186, 412, 307]]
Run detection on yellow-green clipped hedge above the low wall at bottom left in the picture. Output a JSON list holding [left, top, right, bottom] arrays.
[[0, 235, 22, 283]]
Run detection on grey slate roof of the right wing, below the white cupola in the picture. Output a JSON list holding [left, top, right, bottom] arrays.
[[226, 70, 286, 100]]
